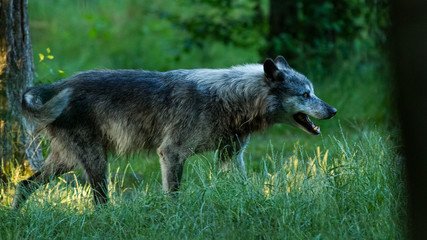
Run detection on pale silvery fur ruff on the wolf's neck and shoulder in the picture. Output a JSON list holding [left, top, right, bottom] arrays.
[[185, 64, 276, 135]]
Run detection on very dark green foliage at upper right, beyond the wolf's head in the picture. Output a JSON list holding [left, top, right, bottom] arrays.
[[266, 0, 389, 66]]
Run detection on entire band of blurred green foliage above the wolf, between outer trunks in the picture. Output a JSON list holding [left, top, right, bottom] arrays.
[[29, 0, 389, 75]]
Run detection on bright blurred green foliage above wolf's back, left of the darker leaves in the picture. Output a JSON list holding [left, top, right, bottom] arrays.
[[29, 0, 262, 82]]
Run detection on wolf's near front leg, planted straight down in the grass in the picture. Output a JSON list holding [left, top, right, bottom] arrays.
[[157, 146, 187, 193]]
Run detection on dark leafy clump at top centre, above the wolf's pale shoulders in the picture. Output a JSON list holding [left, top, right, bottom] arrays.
[[169, 0, 266, 50]]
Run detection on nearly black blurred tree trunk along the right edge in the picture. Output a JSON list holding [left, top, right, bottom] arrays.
[[390, 0, 427, 239]]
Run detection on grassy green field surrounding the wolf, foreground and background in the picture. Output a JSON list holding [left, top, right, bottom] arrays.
[[0, 0, 407, 239]]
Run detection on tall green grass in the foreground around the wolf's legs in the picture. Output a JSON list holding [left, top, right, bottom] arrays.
[[0, 127, 406, 239]]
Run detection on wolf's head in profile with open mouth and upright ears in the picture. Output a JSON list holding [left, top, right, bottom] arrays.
[[264, 56, 337, 135]]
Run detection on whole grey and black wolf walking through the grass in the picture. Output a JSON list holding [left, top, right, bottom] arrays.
[[12, 56, 337, 209]]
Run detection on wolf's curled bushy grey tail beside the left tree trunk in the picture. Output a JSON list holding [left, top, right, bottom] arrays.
[[22, 87, 72, 127]]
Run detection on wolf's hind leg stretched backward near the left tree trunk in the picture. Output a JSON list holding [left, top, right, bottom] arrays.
[[11, 152, 74, 209]]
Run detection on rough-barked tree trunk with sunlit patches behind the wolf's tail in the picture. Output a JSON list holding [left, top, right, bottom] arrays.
[[0, 0, 43, 180]]
